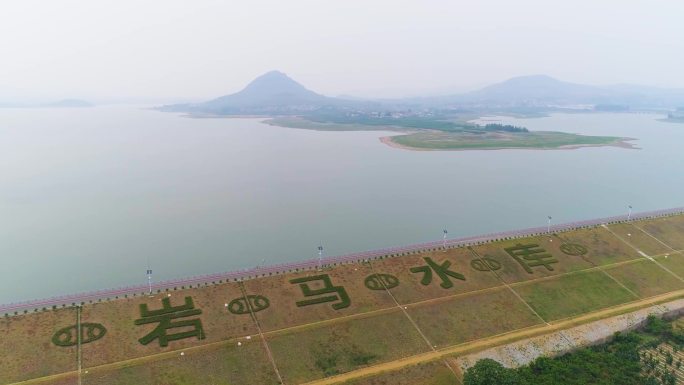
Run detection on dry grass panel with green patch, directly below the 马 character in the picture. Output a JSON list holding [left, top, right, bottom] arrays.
[[267, 310, 429, 384]]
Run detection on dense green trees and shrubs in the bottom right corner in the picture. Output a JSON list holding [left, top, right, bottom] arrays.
[[463, 316, 684, 385]]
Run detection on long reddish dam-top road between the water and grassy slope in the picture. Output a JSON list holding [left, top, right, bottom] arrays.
[[0, 207, 684, 316]]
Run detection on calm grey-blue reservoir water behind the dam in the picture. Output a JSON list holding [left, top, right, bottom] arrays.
[[0, 107, 684, 303]]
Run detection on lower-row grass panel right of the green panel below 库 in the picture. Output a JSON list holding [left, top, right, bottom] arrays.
[[606, 260, 684, 298]]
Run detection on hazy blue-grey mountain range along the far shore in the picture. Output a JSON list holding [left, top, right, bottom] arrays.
[[159, 71, 684, 115]]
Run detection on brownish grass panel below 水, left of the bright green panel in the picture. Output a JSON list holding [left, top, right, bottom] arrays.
[[407, 288, 542, 348]]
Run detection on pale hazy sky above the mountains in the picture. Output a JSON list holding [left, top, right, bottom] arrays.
[[0, 0, 684, 101]]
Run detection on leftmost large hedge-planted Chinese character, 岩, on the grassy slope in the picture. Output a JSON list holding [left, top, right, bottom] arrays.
[[135, 297, 205, 347]]
